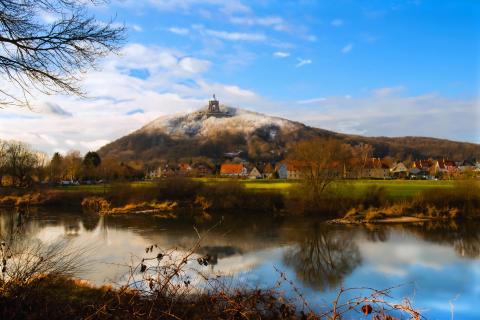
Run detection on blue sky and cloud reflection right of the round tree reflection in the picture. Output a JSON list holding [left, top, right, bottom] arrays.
[[345, 233, 480, 319]]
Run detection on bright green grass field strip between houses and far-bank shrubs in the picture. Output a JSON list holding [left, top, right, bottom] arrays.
[[52, 178, 462, 199]]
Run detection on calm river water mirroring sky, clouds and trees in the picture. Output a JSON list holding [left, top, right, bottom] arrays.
[[0, 210, 480, 319]]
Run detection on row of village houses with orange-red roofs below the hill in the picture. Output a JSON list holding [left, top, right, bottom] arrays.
[[147, 158, 480, 179]]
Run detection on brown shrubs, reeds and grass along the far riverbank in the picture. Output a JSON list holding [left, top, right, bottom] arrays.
[[0, 178, 480, 223]]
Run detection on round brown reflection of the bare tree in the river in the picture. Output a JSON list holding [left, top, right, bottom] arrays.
[[284, 224, 361, 290]]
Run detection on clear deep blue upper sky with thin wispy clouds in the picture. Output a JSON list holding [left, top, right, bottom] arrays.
[[107, 0, 480, 100]]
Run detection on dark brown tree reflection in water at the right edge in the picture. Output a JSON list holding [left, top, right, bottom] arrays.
[[405, 220, 480, 258]]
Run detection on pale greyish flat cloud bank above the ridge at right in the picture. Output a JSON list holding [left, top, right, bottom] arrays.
[[284, 91, 480, 141]]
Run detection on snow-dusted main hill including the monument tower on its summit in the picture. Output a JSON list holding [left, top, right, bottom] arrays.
[[99, 100, 335, 161]]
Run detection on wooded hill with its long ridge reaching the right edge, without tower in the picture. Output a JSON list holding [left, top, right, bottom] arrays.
[[99, 106, 480, 162]]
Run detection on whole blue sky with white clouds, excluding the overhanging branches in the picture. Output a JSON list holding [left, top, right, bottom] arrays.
[[0, 0, 480, 153]]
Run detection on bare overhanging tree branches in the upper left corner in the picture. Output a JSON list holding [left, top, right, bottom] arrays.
[[0, 0, 124, 107]]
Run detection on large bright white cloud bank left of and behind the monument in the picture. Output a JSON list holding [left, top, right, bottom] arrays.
[[0, 44, 265, 153]]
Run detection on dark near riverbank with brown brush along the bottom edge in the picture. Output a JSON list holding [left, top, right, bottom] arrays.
[[0, 276, 421, 320]]
